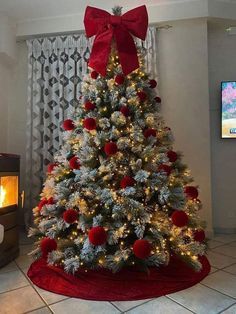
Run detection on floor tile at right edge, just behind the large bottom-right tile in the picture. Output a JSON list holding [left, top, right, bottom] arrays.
[[202, 271, 236, 298]]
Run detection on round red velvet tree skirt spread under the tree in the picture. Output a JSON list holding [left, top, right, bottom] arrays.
[[28, 257, 211, 301]]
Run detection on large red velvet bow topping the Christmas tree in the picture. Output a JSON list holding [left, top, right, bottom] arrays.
[[84, 5, 148, 76]]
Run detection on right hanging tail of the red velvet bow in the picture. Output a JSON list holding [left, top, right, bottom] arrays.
[[114, 28, 139, 75]]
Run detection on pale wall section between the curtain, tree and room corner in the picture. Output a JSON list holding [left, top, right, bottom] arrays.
[[158, 19, 212, 232]]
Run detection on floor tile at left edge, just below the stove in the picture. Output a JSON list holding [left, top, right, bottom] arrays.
[[0, 270, 29, 293]]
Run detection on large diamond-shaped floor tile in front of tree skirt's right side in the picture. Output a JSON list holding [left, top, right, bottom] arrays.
[[168, 284, 235, 314]]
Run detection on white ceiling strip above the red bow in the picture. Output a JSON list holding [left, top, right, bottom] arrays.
[[0, 0, 190, 21]]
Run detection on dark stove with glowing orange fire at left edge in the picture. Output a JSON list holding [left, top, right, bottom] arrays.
[[0, 154, 20, 267]]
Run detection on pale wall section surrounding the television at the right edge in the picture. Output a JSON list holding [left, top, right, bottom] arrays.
[[208, 22, 236, 232]]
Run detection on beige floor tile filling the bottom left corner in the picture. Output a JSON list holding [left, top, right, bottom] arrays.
[[0, 286, 45, 314]]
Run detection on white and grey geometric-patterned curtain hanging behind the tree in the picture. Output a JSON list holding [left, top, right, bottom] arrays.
[[25, 27, 157, 226]]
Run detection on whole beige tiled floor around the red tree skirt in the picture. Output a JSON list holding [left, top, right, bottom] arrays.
[[0, 235, 236, 314]]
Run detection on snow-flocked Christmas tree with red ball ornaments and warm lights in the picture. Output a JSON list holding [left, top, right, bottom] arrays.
[[30, 8, 205, 273]]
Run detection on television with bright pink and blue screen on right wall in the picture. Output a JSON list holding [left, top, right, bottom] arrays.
[[221, 81, 236, 138]]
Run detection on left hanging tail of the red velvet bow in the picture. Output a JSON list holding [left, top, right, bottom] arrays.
[[89, 29, 113, 76]]
